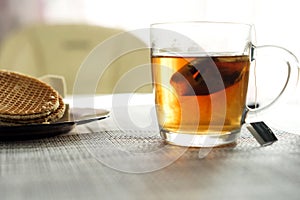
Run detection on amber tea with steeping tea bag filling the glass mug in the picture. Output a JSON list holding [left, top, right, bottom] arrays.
[[152, 55, 250, 135]]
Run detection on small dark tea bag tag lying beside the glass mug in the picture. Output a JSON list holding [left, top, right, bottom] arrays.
[[246, 121, 278, 146]]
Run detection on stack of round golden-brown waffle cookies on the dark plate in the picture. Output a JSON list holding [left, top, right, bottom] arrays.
[[0, 70, 66, 126]]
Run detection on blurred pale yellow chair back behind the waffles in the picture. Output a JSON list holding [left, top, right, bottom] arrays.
[[0, 24, 151, 94]]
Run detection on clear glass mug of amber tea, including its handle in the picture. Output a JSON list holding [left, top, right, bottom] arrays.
[[150, 22, 298, 147]]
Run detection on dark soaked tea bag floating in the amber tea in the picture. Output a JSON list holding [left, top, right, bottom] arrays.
[[170, 57, 242, 96]]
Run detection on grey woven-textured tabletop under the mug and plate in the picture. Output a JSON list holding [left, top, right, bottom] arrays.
[[0, 95, 300, 200]]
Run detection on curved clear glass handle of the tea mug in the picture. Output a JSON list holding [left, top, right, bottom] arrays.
[[242, 45, 300, 123]]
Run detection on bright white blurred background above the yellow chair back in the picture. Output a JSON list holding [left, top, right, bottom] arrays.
[[0, 0, 300, 53]]
